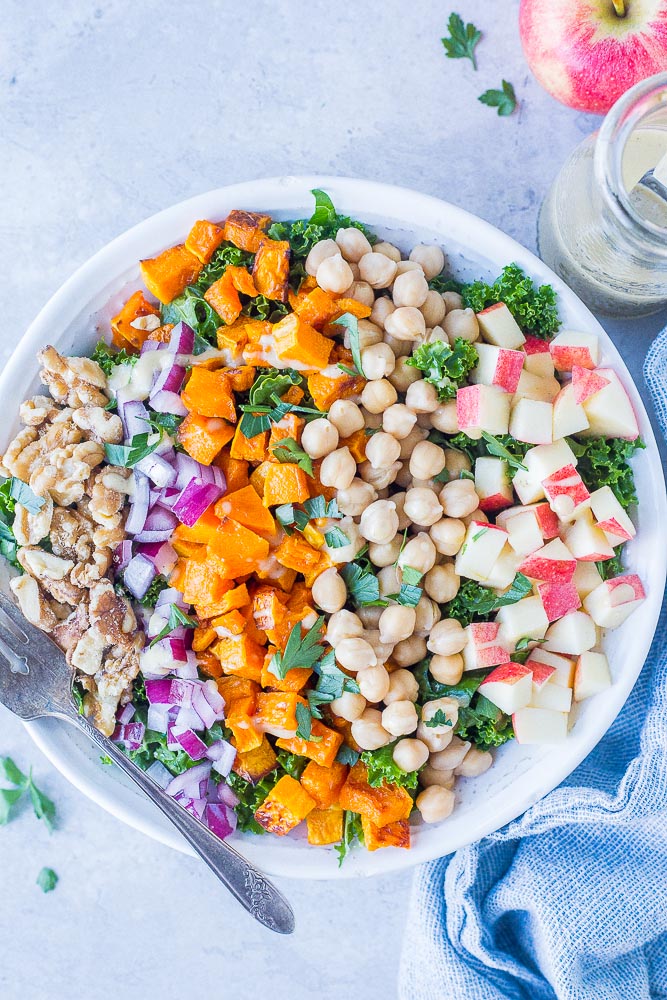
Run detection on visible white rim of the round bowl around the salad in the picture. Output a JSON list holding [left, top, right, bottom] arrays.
[[0, 177, 667, 878]]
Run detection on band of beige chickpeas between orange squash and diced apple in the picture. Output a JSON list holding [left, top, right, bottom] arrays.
[[301, 228, 492, 823]]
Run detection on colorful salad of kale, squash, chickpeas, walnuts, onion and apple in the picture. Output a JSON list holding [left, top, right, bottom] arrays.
[[0, 190, 645, 859]]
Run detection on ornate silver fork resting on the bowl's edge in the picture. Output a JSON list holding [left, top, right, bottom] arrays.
[[0, 591, 294, 934]]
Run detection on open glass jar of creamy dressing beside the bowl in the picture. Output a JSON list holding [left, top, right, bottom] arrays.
[[538, 73, 667, 316]]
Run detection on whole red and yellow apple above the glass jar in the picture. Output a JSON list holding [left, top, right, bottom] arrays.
[[519, 0, 667, 114]]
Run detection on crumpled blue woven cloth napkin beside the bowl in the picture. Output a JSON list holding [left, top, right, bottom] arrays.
[[400, 330, 667, 1000]]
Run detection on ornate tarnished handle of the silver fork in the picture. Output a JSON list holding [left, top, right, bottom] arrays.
[[62, 712, 294, 934]]
